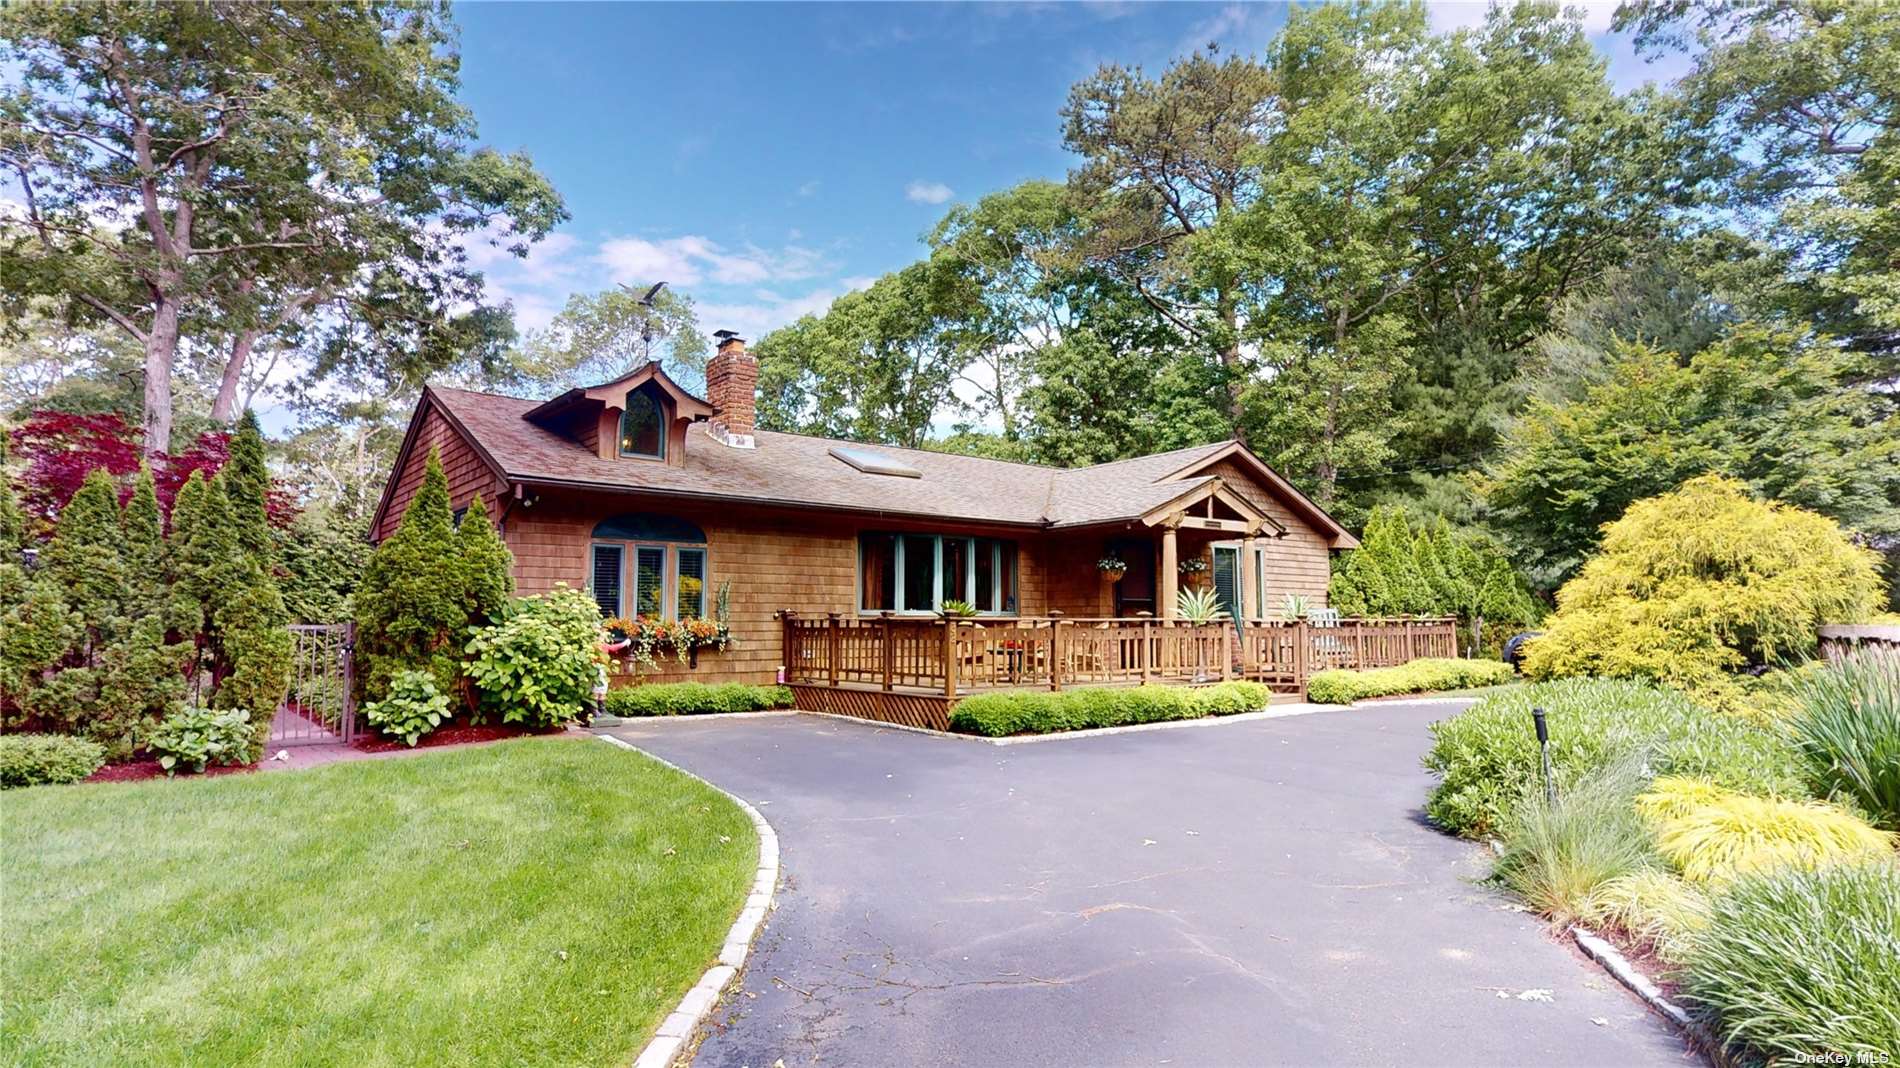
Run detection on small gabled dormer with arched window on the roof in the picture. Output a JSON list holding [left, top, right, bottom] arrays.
[[521, 361, 716, 467]]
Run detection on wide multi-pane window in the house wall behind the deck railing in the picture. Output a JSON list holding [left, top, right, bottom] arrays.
[[857, 532, 1017, 616]]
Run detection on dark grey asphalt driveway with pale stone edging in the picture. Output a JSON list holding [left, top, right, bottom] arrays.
[[614, 703, 1701, 1068]]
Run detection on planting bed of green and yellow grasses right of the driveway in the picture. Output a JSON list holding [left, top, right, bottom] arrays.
[[1425, 659, 1900, 1062]]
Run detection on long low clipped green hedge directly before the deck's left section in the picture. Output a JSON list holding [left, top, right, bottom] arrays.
[[950, 682, 1273, 737]]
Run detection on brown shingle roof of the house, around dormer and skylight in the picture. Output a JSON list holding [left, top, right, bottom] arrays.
[[428, 386, 1314, 526]]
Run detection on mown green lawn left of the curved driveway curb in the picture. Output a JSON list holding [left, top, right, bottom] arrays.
[[0, 739, 758, 1068]]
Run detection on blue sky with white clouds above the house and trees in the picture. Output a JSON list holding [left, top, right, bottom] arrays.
[[456, 2, 1659, 340]]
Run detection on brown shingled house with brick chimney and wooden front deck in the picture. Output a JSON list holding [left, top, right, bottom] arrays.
[[372, 336, 1451, 722]]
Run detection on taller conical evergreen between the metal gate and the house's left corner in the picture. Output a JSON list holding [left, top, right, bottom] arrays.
[[355, 448, 469, 697]]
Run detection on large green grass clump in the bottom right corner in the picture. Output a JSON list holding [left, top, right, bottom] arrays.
[[1682, 859, 1900, 1064]]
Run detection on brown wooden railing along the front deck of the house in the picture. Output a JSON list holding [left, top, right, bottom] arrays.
[[781, 612, 1457, 699]]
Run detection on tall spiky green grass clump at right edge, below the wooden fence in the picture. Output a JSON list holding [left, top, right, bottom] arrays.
[[1788, 652, 1900, 830]]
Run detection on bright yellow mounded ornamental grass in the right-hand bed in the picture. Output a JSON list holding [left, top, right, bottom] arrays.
[[1636, 777, 1892, 884]]
